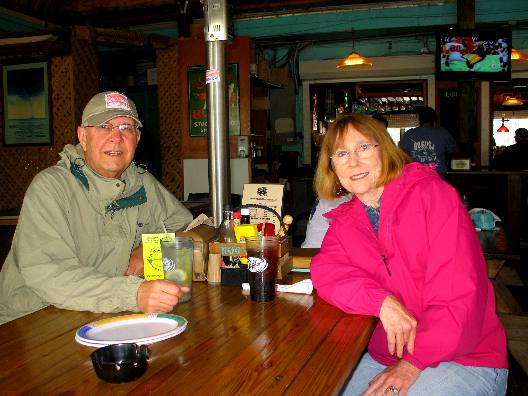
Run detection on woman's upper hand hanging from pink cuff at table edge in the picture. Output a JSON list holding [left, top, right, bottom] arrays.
[[380, 295, 416, 358]]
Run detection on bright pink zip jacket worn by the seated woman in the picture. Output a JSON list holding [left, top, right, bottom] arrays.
[[310, 163, 508, 370]]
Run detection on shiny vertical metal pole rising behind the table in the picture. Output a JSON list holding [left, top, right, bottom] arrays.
[[203, 0, 231, 227]]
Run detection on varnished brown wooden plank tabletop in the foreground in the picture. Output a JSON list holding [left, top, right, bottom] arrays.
[[0, 279, 375, 396]]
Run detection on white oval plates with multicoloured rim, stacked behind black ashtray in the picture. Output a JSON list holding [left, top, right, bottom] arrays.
[[75, 314, 187, 347]]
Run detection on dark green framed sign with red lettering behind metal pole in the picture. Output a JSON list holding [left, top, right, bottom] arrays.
[[187, 63, 240, 136]]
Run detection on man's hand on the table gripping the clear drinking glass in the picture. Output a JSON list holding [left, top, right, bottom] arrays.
[[137, 280, 189, 313]]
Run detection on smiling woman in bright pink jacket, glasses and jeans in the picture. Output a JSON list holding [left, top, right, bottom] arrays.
[[311, 114, 508, 396]]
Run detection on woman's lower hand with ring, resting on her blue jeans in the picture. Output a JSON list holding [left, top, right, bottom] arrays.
[[363, 360, 421, 396]]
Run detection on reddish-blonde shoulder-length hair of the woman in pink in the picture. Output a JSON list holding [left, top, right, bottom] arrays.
[[314, 113, 411, 199]]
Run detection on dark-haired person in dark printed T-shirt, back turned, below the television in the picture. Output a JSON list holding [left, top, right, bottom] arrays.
[[399, 107, 458, 175]]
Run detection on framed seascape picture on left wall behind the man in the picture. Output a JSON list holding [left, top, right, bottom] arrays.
[[2, 62, 52, 145]]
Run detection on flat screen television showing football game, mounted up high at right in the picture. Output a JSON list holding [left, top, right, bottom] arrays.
[[435, 29, 512, 81]]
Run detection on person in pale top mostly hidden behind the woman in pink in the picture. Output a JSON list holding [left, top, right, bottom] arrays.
[[301, 113, 389, 248]]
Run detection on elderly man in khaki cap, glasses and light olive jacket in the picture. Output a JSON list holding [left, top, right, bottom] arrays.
[[0, 92, 192, 323]]
